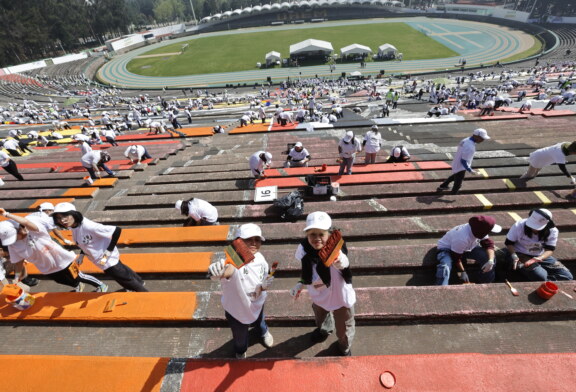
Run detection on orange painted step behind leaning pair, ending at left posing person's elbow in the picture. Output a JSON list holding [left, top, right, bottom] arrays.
[[26, 252, 214, 275]]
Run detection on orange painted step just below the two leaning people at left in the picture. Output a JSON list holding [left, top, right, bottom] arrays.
[[0, 291, 196, 322]]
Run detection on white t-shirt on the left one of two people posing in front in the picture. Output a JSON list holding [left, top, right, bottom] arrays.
[[220, 252, 268, 324]]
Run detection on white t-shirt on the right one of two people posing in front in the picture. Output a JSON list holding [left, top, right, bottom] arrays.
[[294, 245, 356, 312]]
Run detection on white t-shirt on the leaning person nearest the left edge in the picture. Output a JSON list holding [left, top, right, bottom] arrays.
[[8, 213, 76, 275]]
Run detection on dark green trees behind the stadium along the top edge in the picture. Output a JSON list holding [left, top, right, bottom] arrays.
[[0, 0, 576, 67]]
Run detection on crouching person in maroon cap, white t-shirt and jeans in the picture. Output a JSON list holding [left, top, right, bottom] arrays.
[[436, 215, 502, 286]]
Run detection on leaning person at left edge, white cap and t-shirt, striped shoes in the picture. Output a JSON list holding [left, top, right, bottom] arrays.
[[0, 208, 108, 292]]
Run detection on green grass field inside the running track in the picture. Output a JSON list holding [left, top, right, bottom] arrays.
[[127, 23, 458, 76]]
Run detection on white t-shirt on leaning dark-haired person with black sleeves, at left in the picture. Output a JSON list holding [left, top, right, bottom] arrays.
[[71, 217, 120, 270]]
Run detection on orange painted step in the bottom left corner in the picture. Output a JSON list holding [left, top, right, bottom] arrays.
[[0, 355, 170, 392]]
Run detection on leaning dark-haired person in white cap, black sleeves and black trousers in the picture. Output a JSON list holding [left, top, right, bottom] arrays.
[[52, 203, 148, 292]]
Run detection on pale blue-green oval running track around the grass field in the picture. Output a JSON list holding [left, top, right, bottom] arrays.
[[98, 17, 534, 88]]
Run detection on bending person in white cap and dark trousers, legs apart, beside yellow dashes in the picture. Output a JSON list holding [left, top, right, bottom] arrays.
[[436, 128, 490, 195]]
